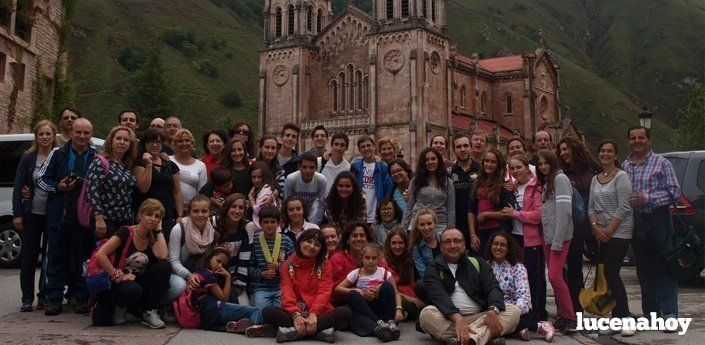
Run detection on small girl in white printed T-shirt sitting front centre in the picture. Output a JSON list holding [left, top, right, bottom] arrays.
[[335, 243, 404, 341]]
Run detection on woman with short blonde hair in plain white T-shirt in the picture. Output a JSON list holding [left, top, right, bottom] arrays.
[[169, 128, 208, 212]]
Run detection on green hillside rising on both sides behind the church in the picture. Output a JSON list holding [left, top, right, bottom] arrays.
[[70, 0, 705, 150]]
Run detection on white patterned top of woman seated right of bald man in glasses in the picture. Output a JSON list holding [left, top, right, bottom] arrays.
[[490, 260, 531, 315]]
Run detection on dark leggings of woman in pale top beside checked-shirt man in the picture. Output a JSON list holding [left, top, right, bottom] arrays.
[[600, 238, 631, 317]]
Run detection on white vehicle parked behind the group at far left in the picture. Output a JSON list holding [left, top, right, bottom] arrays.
[[0, 133, 104, 268]]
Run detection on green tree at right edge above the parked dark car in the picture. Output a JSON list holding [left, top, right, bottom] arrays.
[[674, 83, 705, 150]]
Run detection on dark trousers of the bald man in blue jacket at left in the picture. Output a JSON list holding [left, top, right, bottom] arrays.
[[44, 224, 93, 303]]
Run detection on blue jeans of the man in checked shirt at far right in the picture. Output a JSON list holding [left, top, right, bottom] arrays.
[[632, 207, 678, 317]]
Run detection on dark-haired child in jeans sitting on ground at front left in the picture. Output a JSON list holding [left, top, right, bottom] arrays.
[[184, 247, 263, 333]]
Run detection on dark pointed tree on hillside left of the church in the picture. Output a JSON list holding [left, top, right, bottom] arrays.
[[127, 49, 174, 123]]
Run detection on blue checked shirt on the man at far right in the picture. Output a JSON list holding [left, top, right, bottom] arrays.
[[622, 150, 681, 213]]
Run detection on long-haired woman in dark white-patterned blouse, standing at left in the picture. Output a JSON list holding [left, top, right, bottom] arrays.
[[86, 126, 137, 239]]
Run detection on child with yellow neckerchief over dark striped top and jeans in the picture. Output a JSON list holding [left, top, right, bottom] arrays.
[[248, 205, 294, 309]]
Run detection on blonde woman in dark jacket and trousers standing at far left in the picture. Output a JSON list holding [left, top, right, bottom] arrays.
[[12, 120, 56, 311]]
